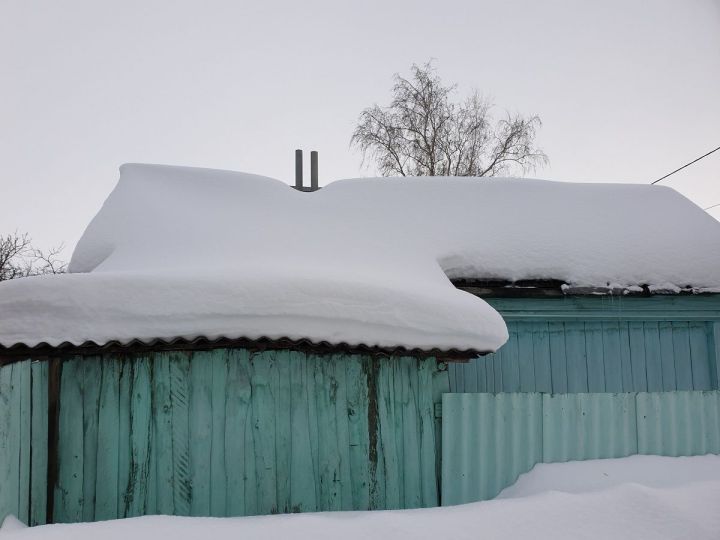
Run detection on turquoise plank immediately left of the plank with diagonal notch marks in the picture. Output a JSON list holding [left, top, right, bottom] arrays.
[[152, 352, 175, 515]]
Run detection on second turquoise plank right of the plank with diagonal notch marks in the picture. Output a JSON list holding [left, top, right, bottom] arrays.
[[210, 349, 229, 517]]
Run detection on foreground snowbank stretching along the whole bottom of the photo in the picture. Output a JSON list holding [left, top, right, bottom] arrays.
[[0, 482, 720, 540]]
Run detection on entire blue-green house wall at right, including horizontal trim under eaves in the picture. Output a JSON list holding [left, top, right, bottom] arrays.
[[450, 295, 720, 393]]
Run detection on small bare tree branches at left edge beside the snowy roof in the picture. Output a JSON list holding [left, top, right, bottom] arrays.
[[0, 232, 67, 281]]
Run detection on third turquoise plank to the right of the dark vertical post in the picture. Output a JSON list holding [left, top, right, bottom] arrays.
[[95, 354, 122, 520]]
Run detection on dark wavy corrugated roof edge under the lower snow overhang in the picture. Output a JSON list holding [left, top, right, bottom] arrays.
[[0, 337, 492, 366]]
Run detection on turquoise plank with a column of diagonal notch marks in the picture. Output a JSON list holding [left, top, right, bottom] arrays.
[[170, 352, 193, 516]]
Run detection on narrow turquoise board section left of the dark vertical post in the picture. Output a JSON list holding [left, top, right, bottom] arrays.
[[0, 360, 48, 525]]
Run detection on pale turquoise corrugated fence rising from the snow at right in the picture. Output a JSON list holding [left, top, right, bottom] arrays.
[[442, 391, 720, 505]]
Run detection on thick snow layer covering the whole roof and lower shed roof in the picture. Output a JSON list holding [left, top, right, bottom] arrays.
[[0, 165, 720, 352]]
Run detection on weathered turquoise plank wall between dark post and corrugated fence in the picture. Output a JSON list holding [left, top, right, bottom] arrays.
[[54, 349, 446, 522]]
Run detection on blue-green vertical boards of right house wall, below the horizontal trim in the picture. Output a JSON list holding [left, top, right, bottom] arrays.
[[450, 320, 718, 393]]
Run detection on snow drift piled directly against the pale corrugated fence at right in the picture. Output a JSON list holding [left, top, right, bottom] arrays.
[[497, 454, 720, 499]]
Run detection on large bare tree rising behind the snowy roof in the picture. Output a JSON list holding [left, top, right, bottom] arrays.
[[350, 62, 547, 176]]
